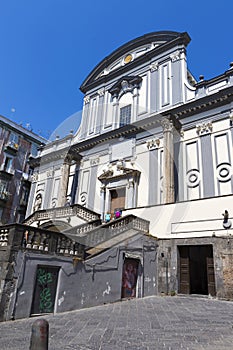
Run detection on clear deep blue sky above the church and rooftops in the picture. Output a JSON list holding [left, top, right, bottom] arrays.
[[0, 0, 233, 137]]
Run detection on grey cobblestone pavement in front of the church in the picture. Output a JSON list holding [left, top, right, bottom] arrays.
[[0, 296, 233, 350]]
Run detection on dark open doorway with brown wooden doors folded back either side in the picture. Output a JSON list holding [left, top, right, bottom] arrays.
[[178, 245, 216, 295]]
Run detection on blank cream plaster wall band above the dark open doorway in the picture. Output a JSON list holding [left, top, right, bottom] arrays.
[[123, 195, 233, 238]]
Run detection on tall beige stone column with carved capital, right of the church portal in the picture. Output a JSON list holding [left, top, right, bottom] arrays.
[[161, 118, 175, 203]]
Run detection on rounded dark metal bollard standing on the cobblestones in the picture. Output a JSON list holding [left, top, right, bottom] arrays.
[[29, 319, 49, 350]]
